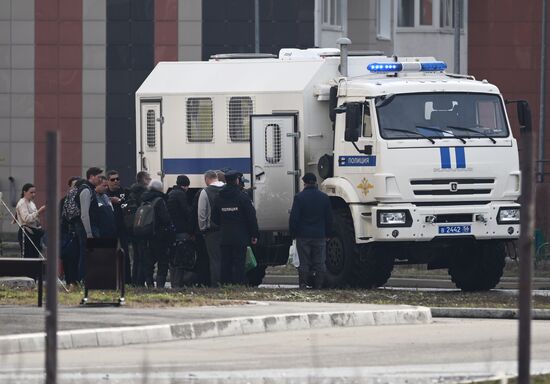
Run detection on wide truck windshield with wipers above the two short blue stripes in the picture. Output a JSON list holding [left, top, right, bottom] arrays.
[[375, 92, 508, 142]]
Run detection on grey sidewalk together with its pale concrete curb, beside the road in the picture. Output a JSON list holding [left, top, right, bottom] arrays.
[[0, 302, 432, 354]]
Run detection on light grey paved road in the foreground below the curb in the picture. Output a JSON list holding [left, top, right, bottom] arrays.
[[0, 319, 550, 384]]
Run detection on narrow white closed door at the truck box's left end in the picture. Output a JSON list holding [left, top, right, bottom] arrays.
[[140, 100, 164, 180]]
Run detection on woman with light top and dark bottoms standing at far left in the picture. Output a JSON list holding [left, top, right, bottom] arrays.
[[15, 183, 46, 258]]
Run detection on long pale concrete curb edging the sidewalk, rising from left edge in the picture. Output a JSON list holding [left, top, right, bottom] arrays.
[[0, 307, 432, 355]]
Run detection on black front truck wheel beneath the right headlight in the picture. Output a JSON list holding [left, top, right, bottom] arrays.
[[449, 241, 506, 292]]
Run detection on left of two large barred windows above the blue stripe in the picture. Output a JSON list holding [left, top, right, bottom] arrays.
[[187, 97, 214, 143]]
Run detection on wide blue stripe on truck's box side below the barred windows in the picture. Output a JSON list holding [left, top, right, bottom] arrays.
[[162, 157, 250, 175]]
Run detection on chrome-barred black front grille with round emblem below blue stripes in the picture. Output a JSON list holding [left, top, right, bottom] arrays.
[[411, 178, 495, 196]]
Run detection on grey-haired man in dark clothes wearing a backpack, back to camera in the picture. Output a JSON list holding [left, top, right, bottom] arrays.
[[142, 180, 172, 288]]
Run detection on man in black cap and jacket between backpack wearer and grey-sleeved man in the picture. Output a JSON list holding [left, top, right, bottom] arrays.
[[167, 175, 193, 287]]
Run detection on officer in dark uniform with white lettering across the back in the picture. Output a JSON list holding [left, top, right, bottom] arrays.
[[212, 170, 259, 284]]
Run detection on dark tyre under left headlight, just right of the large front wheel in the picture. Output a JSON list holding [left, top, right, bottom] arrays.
[[353, 244, 394, 289]]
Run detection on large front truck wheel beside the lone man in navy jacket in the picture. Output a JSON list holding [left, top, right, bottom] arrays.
[[325, 209, 359, 288]]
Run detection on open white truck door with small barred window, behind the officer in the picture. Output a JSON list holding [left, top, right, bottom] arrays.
[[250, 114, 300, 231]]
